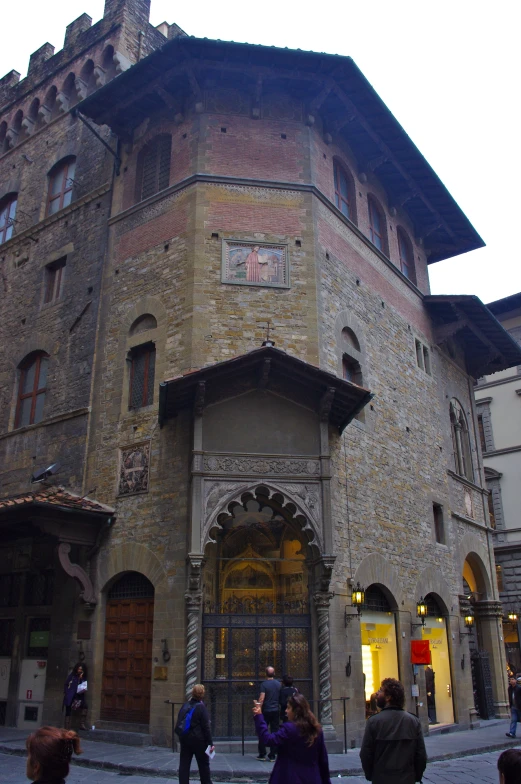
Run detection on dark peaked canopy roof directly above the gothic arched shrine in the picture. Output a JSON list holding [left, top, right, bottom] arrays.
[[159, 346, 372, 433]]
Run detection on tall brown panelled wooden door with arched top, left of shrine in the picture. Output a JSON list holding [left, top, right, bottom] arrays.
[[101, 572, 154, 724]]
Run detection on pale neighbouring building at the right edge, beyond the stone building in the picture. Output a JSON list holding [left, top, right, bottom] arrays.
[[475, 294, 521, 672]]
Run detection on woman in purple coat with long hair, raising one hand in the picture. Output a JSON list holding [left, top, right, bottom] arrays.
[[253, 694, 331, 784]]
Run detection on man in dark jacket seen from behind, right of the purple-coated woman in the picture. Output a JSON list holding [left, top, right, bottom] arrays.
[[360, 678, 427, 784]]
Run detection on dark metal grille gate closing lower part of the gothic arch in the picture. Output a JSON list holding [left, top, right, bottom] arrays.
[[203, 614, 313, 739]]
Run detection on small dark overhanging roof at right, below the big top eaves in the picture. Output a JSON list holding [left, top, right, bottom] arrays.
[[424, 295, 521, 378]]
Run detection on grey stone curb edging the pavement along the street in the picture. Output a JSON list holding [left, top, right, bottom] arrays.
[[0, 738, 519, 784]]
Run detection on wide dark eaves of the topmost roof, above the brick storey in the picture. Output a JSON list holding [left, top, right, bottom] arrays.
[[76, 36, 484, 263]]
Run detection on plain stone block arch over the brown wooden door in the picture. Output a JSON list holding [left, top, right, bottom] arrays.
[[97, 542, 168, 594]]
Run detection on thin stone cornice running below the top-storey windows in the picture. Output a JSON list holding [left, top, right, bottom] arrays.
[[109, 174, 424, 299]]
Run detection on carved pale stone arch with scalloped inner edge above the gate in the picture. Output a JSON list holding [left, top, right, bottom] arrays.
[[201, 480, 324, 556]]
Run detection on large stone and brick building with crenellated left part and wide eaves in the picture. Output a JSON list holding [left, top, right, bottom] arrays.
[[0, 0, 521, 747]]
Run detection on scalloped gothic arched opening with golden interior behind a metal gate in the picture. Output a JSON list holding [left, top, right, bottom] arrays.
[[202, 487, 313, 738]]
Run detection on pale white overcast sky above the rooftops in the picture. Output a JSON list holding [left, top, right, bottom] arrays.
[[0, 0, 521, 302]]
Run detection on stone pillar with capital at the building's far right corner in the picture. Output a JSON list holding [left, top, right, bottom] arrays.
[[474, 600, 509, 719]]
